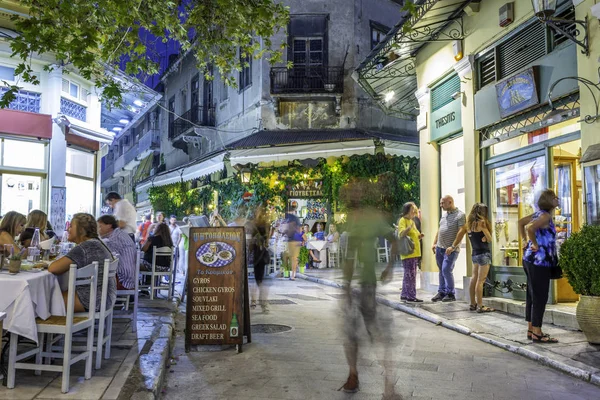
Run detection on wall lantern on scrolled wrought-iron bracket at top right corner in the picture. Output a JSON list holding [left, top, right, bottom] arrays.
[[531, 0, 590, 56]]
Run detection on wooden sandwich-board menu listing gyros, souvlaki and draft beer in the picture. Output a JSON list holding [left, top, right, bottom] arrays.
[[185, 227, 251, 353]]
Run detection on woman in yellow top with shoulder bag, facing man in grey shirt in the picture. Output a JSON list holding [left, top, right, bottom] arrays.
[[398, 202, 423, 303]]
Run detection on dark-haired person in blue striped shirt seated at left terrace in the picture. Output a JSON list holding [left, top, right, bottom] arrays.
[[98, 215, 137, 290]]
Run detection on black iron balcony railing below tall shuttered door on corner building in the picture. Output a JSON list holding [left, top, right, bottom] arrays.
[[270, 66, 344, 95]]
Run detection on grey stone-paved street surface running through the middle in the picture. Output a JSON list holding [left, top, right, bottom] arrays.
[[162, 279, 600, 400]]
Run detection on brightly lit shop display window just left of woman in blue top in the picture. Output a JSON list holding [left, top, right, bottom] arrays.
[[489, 155, 547, 266]]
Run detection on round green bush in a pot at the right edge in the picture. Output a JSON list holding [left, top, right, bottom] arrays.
[[559, 225, 600, 344]]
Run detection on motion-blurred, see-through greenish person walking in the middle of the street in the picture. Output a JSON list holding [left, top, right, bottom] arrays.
[[340, 179, 398, 399]]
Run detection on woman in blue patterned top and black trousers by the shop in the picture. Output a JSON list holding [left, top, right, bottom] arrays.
[[519, 189, 558, 343]]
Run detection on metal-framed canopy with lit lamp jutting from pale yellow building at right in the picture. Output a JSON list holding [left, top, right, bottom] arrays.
[[353, 0, 472, 119]]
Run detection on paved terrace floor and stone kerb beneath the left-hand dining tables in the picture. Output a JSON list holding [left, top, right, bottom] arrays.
[[0, 278, 181, 400]]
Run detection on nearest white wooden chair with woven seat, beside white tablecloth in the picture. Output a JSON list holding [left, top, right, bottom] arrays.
[[6, 262, 98, 393]]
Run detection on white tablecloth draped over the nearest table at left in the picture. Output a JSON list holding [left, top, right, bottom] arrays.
[[0, 270, 66, 343]]
